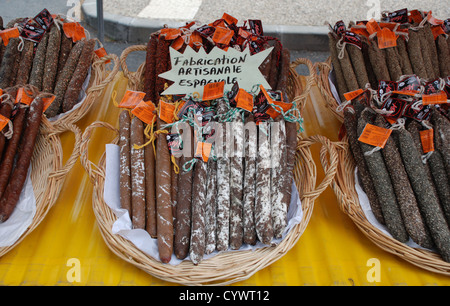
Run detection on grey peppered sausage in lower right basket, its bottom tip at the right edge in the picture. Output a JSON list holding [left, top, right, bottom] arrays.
[[392, 129, 450, 262]]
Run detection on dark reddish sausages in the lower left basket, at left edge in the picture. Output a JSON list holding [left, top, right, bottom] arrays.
[[0, 87, 48, 222]]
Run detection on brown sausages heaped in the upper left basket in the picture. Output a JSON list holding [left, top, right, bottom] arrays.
[[0, 11, 95, 118]]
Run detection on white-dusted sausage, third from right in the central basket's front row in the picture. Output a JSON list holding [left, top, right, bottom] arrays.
[[255, 122, 273, 245]]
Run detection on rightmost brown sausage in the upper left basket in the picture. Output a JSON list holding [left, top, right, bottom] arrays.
[[62, 39, 95, 113]]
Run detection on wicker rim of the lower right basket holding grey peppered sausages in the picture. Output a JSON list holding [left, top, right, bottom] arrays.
[[324, 136, 450, 276]]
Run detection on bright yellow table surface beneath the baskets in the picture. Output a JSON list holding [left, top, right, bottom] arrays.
[[0, 72, 450, 286]]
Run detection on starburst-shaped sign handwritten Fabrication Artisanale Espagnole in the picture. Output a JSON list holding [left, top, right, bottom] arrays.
[[159, 46, 273, 96]]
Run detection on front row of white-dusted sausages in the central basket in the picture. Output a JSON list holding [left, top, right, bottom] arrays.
[[119, 99, 297, 264]]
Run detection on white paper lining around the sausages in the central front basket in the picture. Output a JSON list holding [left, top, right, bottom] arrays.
[[103, 144, 303, 265]]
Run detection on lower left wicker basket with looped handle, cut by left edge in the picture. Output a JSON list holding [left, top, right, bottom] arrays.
[[0, 117, 81, 256]]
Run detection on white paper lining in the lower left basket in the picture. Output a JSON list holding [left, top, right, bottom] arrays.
[[0, 165, 36, 247]]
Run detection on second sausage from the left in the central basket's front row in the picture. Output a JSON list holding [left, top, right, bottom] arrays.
[[130, 117, 145, 229]]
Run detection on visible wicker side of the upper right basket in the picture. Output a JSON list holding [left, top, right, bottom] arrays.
[[314, 57, 344, 122]]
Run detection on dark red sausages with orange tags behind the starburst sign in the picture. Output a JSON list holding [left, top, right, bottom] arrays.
[[143, 14, 290, 105]]
